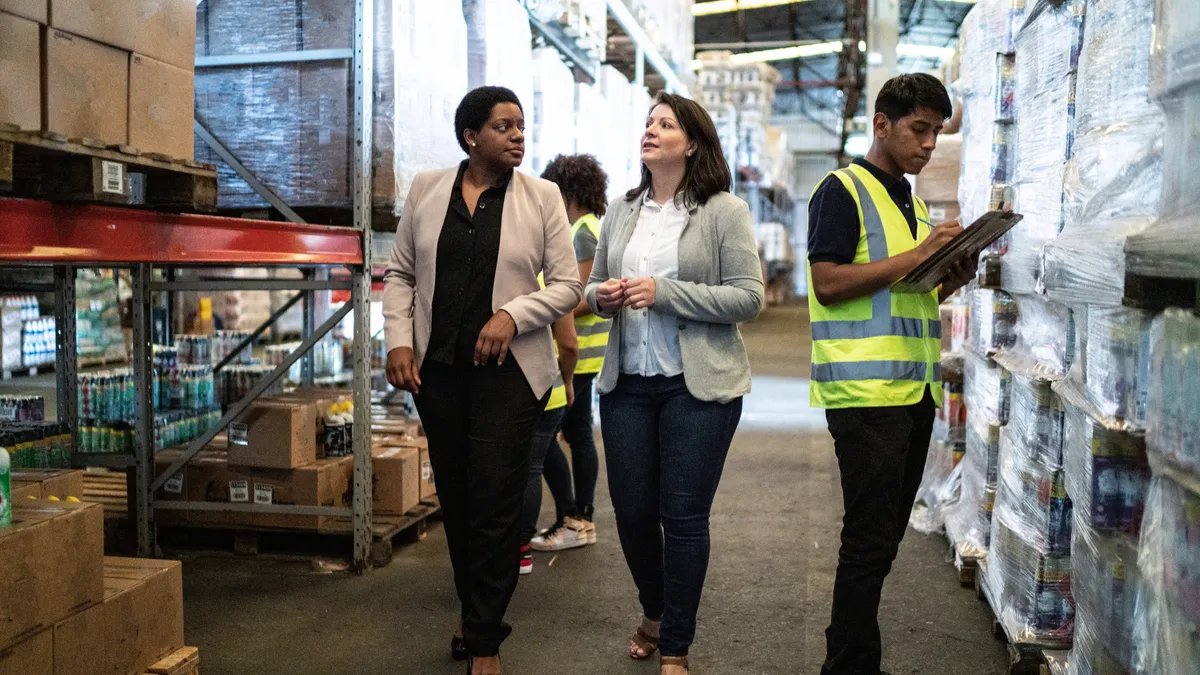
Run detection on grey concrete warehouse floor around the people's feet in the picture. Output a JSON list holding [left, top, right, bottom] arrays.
[[175, 309, 1006, 675]]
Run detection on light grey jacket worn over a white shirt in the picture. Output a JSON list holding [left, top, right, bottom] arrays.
[[587, 192, 763, 402]]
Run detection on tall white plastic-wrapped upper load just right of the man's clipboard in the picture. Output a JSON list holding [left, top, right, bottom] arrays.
[[1001, 0, 1086, 293]]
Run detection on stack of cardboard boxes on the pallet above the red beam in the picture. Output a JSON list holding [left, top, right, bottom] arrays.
[[0, 0, 196, 160]]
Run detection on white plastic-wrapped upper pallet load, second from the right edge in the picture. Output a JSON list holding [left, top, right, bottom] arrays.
[[1044, 0, 1165, 305]]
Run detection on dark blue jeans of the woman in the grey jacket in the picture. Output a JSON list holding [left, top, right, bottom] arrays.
[[600, 375, 742, 656]]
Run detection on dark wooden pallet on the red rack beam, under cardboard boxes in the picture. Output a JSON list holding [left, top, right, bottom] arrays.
[[0, 124, 217, 213]]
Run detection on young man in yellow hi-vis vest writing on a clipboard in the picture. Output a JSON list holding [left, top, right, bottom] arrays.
[[808, 73, 977, 675]]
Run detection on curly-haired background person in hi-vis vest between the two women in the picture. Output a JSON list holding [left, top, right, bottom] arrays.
[[532, 155, 612, 551]]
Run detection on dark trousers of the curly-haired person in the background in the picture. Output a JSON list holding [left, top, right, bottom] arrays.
[[542, 374, 600, 520]]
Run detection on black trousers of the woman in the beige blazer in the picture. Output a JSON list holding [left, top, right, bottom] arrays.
[[414, 354, 548, 657]]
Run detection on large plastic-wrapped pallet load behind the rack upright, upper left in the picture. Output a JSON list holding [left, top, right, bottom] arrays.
[[196, 0, 468, 213]]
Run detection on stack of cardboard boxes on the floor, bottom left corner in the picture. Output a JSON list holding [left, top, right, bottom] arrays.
[[0, 500, 184, 675]]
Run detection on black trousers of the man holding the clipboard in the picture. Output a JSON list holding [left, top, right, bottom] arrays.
[[821, 389, 936, 675]]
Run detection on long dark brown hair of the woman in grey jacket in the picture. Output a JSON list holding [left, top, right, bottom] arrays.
[[625, 91, 733, 207]]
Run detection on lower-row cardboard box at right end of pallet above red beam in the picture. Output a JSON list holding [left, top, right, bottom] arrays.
[[128, 54, 196, 160]]
